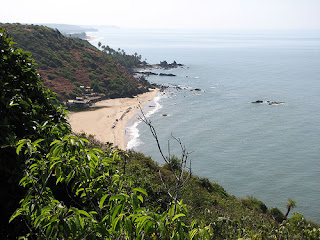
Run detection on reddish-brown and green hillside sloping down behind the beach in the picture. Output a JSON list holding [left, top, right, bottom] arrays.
[[0, 23, 148, 100]]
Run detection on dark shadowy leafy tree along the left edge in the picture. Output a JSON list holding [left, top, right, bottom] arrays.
[[0, 29, 70, 238]]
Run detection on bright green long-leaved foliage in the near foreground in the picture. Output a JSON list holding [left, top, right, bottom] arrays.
[[10, 135, 211, 239]]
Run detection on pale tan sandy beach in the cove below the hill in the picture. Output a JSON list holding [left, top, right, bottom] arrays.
[[69, 89, 158, 150]]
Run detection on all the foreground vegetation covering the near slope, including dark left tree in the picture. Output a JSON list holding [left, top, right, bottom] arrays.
[[0, 27, 320, 239]]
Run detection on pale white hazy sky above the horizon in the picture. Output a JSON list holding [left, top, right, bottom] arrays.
[[0, 0, 320, 29]]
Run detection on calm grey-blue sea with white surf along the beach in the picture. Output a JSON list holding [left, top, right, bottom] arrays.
[[88, 26, 320, 223]]
